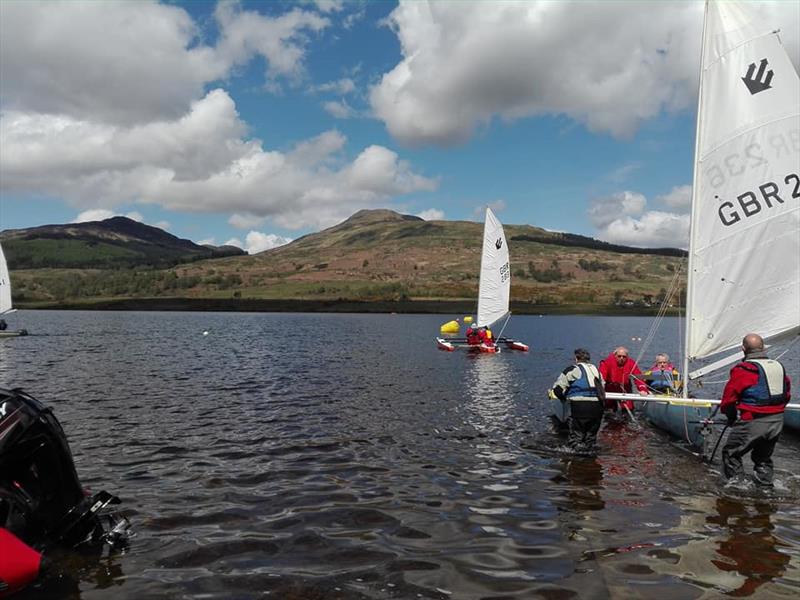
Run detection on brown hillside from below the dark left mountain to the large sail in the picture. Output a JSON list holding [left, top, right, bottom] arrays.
[[3, 210, 683, 312]]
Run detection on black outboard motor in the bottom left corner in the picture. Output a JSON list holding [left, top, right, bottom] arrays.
[[0, 389, 130, 550]]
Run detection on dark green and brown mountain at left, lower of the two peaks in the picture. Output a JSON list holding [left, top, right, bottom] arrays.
[[0, 217, 245, 270]]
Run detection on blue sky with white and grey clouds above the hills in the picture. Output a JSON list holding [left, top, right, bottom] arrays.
[[0, 0, 800, 254]]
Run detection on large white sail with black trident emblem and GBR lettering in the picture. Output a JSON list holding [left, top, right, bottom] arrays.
[[686, 2, 800, 359]]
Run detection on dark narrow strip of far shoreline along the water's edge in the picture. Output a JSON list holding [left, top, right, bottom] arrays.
[[17, 298, 677, 316]]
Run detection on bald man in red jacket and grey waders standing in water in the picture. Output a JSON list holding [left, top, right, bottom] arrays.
[[719, 333, 791, 487]]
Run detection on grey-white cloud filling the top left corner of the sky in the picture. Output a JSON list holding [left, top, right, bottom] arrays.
[[0, 1, 329, 125]]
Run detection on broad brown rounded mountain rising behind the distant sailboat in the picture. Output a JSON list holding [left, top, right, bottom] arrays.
[[164, 210, 685, 306]]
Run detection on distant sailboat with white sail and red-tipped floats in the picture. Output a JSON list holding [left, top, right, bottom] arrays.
[[436, 207, 529, 352]]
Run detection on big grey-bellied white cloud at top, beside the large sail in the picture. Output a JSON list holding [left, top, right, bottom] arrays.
[[370, 0, 800, 145]]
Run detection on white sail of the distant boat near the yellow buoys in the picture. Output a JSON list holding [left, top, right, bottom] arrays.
[[477, 208, 511, 327]]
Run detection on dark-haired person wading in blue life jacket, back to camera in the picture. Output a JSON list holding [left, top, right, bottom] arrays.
[[550, 348, 606, 452]]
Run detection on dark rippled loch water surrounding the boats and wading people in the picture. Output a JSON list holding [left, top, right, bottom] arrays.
[[0, 311, 800, 600]]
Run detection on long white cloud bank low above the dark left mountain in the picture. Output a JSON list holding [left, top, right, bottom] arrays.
[[0, 89, 438, 229]]
